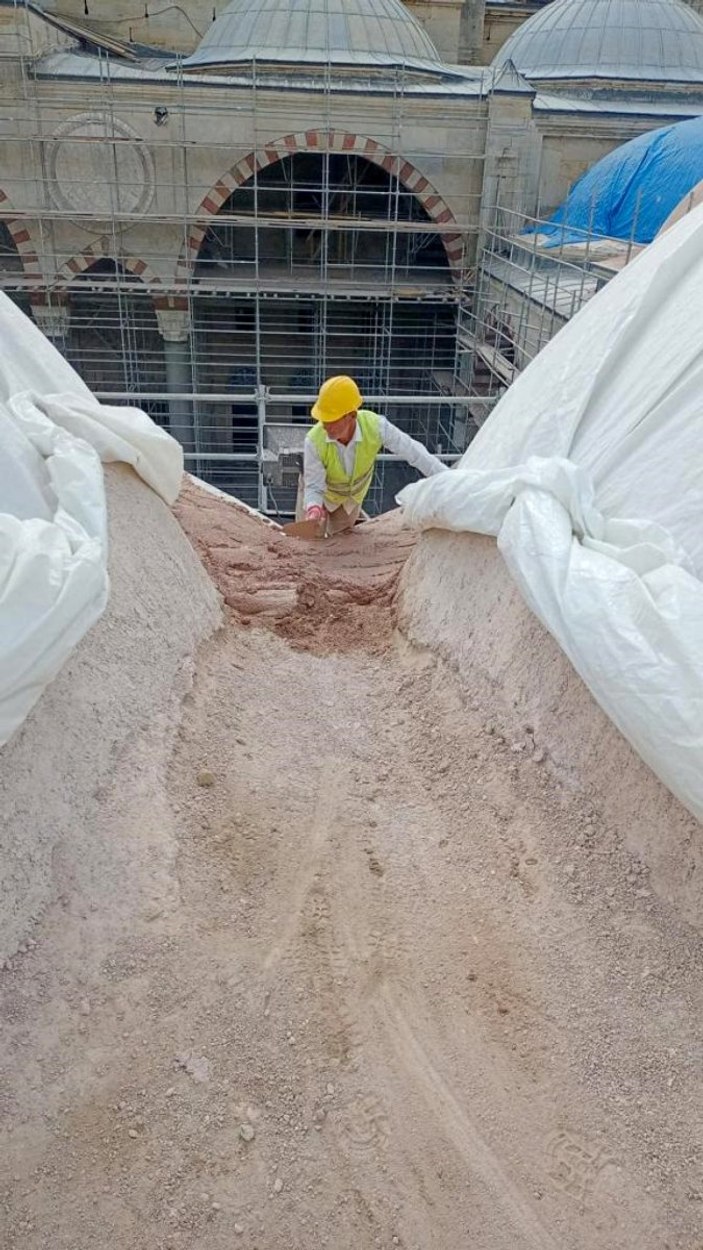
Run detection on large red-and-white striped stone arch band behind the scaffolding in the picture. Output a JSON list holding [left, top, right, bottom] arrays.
[[176, 130, 464, 281]]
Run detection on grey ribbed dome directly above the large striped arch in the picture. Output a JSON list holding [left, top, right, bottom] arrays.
[[183, 0, 442, 70]]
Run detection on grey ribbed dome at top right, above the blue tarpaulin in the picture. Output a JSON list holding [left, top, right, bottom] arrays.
[[493, 0, 703, 84]]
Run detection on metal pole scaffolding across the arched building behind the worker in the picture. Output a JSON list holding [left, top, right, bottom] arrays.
[[0, 0, 607, 515]]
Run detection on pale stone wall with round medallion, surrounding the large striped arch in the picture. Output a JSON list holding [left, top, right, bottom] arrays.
[[0, 73, 485, 283]]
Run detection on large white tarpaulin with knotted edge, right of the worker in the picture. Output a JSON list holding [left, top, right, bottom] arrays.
[[399, 208, 703, 819]]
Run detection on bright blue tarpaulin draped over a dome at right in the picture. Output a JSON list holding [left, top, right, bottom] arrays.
[[539, 118, 703, 246]]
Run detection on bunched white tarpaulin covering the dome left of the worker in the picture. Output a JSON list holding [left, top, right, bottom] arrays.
[[0, 293, 183, 744]]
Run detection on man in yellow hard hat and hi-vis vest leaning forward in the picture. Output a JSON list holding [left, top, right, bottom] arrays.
[[298, 376, 445, 534]]
